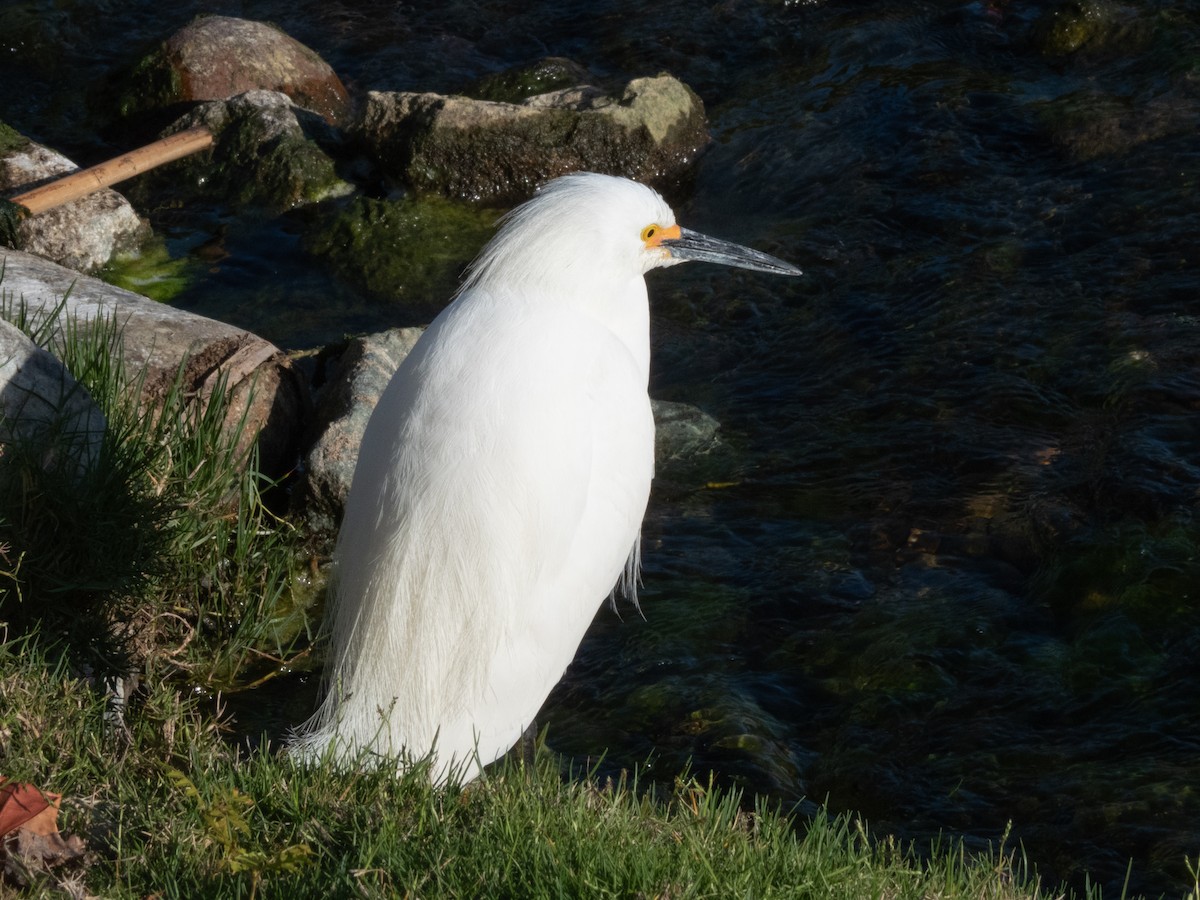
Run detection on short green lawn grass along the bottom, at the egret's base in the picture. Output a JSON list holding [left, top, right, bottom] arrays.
[[0, 637, 1099, 900]]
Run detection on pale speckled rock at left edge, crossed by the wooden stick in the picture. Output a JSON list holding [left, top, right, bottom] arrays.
[[0, 128, 150, 272]]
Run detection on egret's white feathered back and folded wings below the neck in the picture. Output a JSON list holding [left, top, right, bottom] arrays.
[[319, 289, 653, 777]]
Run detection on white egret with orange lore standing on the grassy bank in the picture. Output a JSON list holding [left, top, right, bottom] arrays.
[[290, 173, 800, 781]]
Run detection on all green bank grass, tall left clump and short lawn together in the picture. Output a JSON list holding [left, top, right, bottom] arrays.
[[0, 300, 1166, 900]]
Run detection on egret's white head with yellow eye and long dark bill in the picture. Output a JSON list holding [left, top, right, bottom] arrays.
[[453, 173, 800, 303]]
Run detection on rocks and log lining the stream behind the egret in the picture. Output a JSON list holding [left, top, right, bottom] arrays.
[[0, 16, 718, 532]]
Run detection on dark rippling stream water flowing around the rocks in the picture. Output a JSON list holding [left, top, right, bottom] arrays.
[[0, 0, 1200, 896]]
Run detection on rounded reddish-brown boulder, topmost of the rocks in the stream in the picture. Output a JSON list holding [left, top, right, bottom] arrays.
[[121, 16, 350, 122]]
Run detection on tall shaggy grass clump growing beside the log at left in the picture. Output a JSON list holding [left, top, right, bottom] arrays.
[[0, 292, 312, 690]]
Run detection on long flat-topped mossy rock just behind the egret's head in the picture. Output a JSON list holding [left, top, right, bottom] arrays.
[[359, 74, 708, 204]]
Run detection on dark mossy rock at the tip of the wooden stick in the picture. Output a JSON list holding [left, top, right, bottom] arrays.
[[146, 90, 353, 210]]
